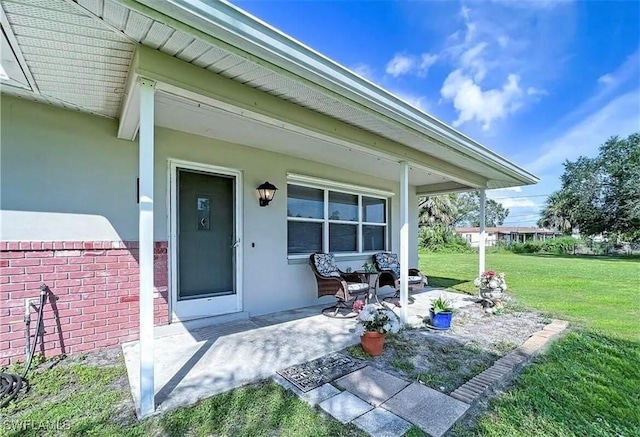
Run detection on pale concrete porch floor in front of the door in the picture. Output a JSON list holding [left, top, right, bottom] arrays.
[[122, 288, 472, 414]]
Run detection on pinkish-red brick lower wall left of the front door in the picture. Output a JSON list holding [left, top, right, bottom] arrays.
[[0, 241, 169, 365]]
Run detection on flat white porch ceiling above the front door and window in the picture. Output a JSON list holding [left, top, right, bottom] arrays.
[[155, 92, 450, 189]]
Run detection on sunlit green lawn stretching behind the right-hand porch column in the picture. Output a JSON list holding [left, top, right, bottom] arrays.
[[420, 253, 640, 341]]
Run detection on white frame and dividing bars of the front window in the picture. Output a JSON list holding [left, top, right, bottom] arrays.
[[287, 173, 395, 260]]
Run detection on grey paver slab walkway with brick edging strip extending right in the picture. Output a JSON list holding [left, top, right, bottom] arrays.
[[273, 320, 568, 437]]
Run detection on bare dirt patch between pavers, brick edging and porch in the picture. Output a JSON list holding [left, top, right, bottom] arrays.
[[347, 303, 545, 394]]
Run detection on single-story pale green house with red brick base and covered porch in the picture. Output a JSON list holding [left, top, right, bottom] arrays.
[[0, 0, 537, 415]]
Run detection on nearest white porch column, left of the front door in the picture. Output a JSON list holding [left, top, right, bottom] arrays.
[[138, 79, 155, 417]]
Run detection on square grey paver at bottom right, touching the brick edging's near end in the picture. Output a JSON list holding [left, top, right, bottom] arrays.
[[382, 382, 469, 437]]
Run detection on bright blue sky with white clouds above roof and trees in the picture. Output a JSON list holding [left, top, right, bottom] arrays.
[[234, 0, 640, 226]]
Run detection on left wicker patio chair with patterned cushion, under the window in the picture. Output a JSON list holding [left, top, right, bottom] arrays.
[[309, 253, 369, 318]]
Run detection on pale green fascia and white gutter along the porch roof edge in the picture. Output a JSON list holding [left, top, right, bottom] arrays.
[[118, 0, 538, 188]]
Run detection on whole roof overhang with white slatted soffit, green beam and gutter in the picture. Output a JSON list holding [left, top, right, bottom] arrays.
[[0, 0, 537, 195]]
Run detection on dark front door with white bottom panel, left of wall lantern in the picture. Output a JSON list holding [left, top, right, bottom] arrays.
[[173, 168, 239, 320]]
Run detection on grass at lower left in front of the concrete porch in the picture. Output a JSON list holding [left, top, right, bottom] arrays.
[[0, 358, 364, 437]]
